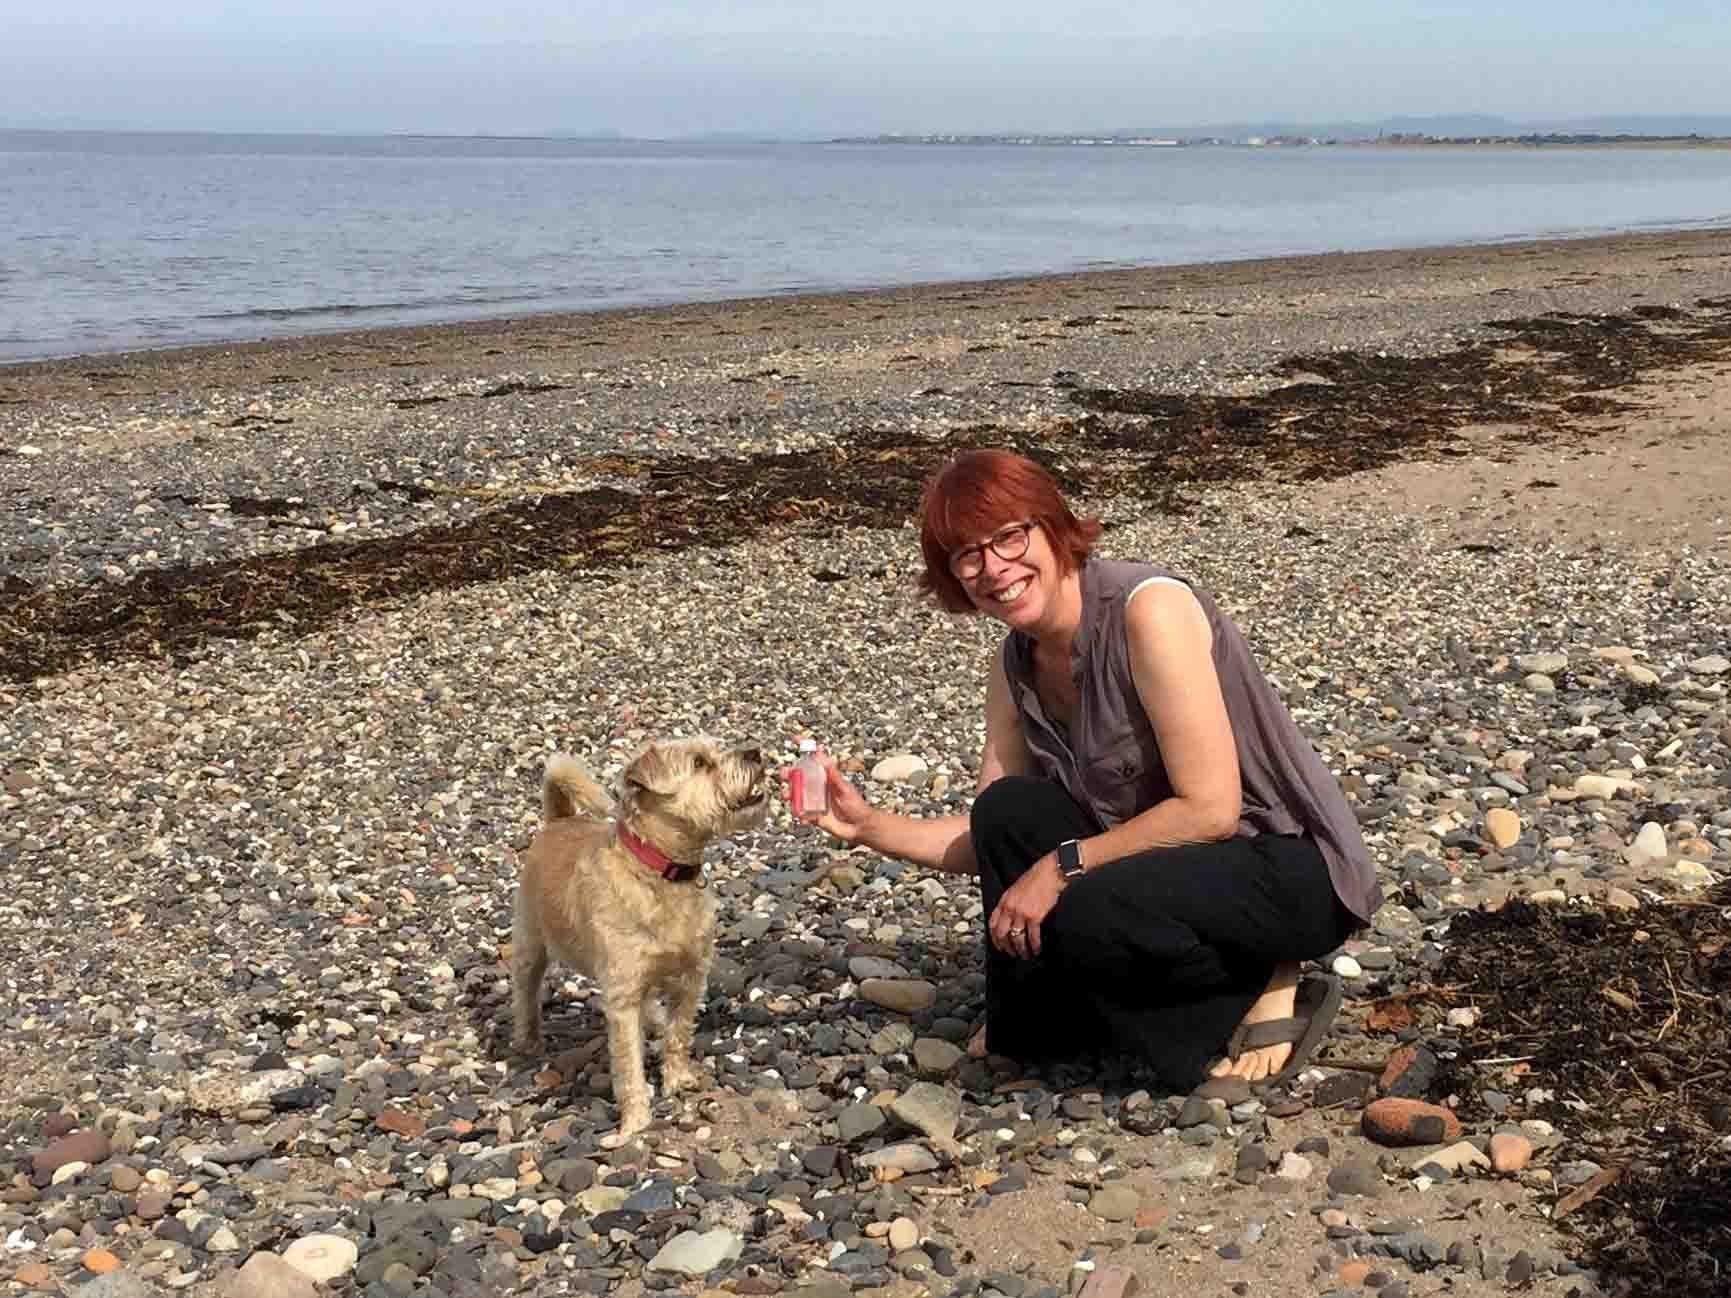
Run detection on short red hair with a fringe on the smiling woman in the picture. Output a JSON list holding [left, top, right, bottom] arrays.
[[919, 450, 1101, 613]]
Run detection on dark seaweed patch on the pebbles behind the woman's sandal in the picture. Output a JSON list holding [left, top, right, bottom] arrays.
[[1438, 884, 1731, 1298]]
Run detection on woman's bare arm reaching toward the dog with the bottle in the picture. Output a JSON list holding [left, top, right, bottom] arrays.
[[812, 661, 1028, 874]]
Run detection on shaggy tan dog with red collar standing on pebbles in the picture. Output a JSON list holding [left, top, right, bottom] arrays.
[[511, 739, 769, 1139]]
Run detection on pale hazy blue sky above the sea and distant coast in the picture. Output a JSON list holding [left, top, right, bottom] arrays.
[[0, 0, 1731, 138]]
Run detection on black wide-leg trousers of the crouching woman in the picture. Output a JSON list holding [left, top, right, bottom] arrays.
[[969, 775, 1359, 1090]]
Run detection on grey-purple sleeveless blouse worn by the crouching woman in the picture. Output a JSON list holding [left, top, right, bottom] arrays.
[[1004, 559, 1383, 922]]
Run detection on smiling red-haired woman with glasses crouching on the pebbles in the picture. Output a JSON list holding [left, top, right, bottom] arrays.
[[792, 450, 1381, 1094]]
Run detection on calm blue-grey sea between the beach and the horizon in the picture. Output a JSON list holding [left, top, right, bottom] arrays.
[[10, 132, 1731, 360]]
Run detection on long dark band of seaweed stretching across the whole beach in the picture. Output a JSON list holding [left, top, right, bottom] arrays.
[[0, 299, 1731, 684]]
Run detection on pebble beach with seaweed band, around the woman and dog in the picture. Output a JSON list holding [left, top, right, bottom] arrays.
[[0, 230, 1731, 1298]]
